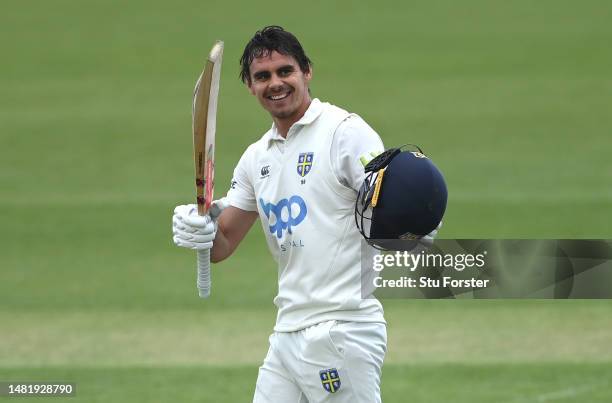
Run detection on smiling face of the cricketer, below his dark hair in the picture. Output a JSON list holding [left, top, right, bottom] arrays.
[[249, 51, 312, 121]]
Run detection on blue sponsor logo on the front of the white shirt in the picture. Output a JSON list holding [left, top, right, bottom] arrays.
[[259, 195, 308, 239]]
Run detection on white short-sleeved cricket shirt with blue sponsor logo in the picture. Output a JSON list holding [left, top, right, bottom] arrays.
[[227, 99, 384, 332]]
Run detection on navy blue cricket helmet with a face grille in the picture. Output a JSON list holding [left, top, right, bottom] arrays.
[[355, 146, 448, 250]]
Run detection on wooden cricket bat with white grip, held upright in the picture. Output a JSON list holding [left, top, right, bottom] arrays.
[[191, 41, 223, 298]]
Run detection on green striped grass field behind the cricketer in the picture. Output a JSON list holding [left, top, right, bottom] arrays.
[[0, 0, 612, 403]]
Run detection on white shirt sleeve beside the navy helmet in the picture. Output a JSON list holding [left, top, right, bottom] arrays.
[[330, 115, 385, 191]]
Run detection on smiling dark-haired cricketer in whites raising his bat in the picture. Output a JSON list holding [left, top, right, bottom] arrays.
[[173, 26, 387, 403]]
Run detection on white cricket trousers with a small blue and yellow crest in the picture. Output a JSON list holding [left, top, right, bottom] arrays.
[[253, 320, 387, 403]]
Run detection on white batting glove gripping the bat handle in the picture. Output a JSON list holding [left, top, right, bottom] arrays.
[[172, 198, 228, 250]]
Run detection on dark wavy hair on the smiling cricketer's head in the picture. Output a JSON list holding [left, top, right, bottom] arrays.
[[240, 25, 312, 85]]
